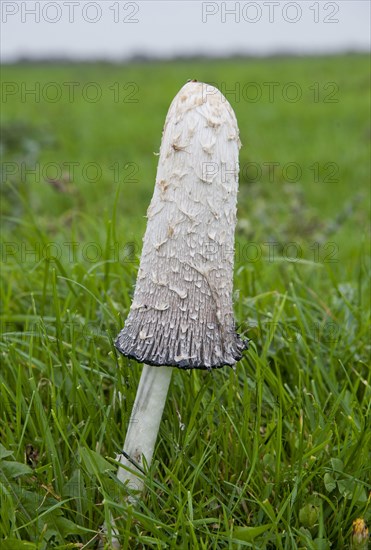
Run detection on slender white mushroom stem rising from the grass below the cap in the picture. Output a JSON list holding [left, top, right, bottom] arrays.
[[117, 365, 172, 496]]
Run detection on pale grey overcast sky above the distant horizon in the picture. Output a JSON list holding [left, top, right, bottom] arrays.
[[1, 0, 371, 62]]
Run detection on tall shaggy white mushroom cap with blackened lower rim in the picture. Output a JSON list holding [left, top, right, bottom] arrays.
[[116, 81, 247, 369]]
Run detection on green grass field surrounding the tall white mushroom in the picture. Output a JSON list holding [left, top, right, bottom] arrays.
[[0, 55, 371, 550]]
